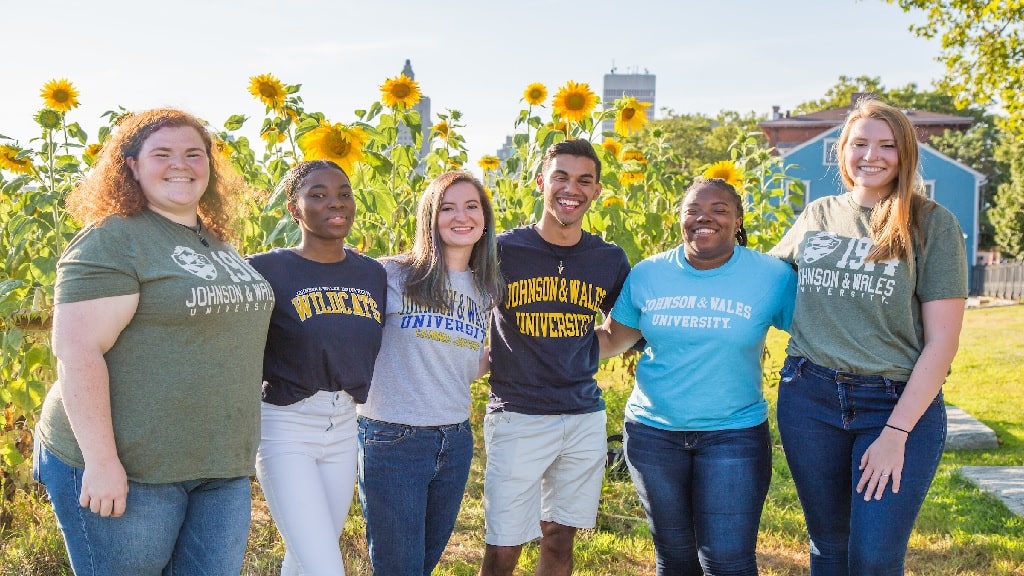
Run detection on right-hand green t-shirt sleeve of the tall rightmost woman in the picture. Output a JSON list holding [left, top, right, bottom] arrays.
[[916, 206, 967, 302]]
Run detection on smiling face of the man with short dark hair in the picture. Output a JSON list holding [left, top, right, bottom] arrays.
[[537, 154, 601, 230]]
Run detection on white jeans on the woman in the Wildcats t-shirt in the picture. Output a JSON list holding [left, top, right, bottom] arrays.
[[256, 390, 358, 576]]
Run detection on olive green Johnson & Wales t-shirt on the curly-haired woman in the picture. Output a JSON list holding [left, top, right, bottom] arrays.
[[38, 210, 273, 484]]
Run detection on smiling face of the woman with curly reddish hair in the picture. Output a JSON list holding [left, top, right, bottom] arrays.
[[125, 126, 210, 225]]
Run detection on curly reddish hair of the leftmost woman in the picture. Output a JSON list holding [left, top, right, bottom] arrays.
[[66, 109, 245, 240]]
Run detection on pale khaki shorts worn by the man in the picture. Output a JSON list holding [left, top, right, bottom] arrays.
[[483, 410, 608, 546]]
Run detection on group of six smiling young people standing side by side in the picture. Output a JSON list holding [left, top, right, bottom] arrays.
[[34, 95, 967, 576]]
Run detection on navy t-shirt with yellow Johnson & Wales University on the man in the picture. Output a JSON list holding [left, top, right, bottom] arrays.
[[487, 227, 630, 414]]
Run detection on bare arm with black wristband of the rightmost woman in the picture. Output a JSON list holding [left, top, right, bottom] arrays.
[[857, 298, 965, 500]]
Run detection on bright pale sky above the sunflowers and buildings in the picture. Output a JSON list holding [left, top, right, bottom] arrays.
[[0, 0, 943, 171]]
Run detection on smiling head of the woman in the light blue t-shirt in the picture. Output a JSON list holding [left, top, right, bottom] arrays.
[[680, 183, 743, 270]]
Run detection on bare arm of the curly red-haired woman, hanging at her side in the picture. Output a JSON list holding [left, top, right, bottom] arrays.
[[53, 294, 138, 517]]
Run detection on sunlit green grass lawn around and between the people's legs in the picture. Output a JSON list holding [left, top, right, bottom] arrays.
[[0, 305, 1024, 576]]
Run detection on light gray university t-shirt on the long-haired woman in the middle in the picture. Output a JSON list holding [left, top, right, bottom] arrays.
[[358, 260, 489, 426]]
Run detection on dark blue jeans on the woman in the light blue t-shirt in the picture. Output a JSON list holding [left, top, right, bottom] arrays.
[[623, 420, 771, 576]]
